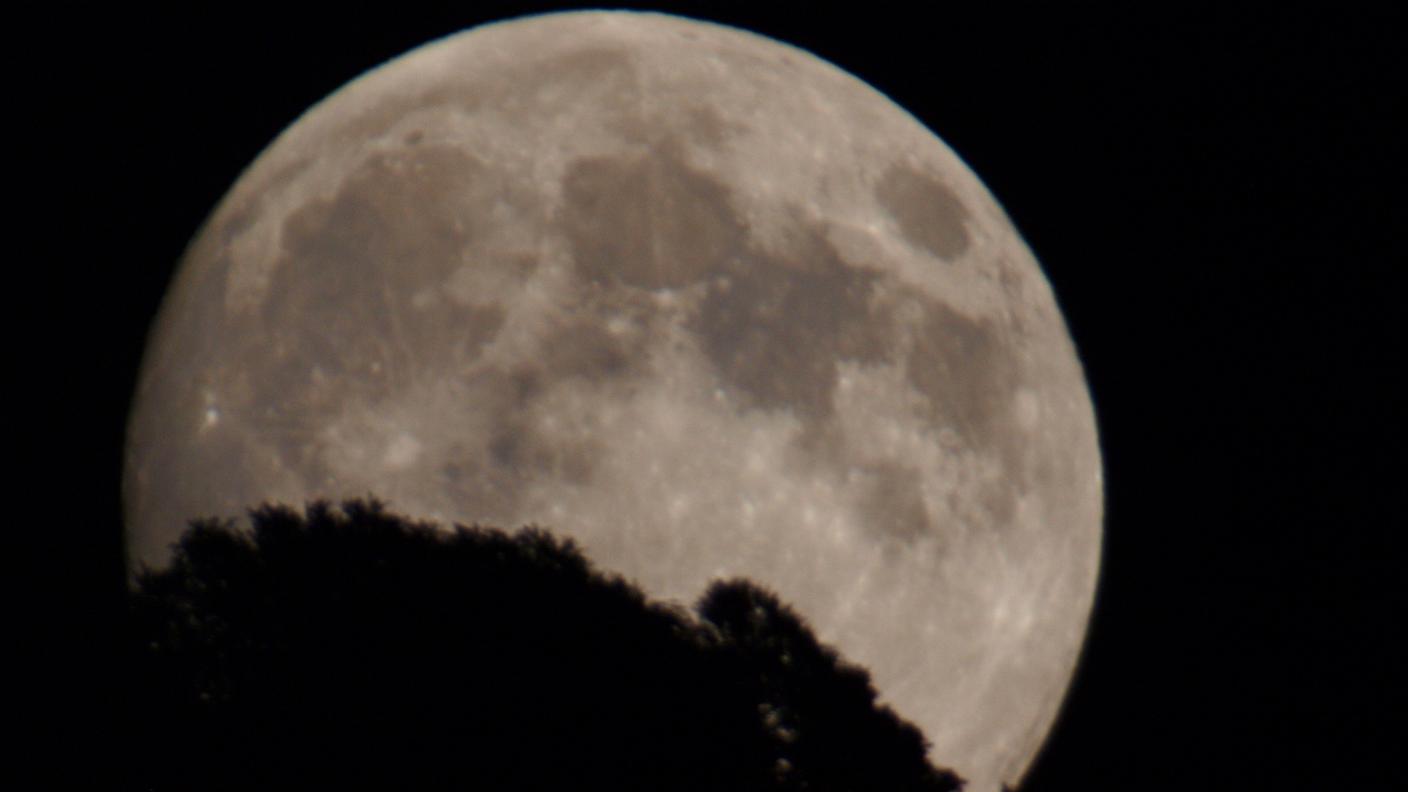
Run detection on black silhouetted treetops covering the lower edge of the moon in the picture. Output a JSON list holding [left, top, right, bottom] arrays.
[[120, 500, 962, 792]]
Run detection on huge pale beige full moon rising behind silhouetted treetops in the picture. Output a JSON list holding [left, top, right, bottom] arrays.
[[124, 11, 1102, 792]]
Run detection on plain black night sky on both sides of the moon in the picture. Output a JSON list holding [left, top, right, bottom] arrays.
[[30, 1, 1408, 791]]
